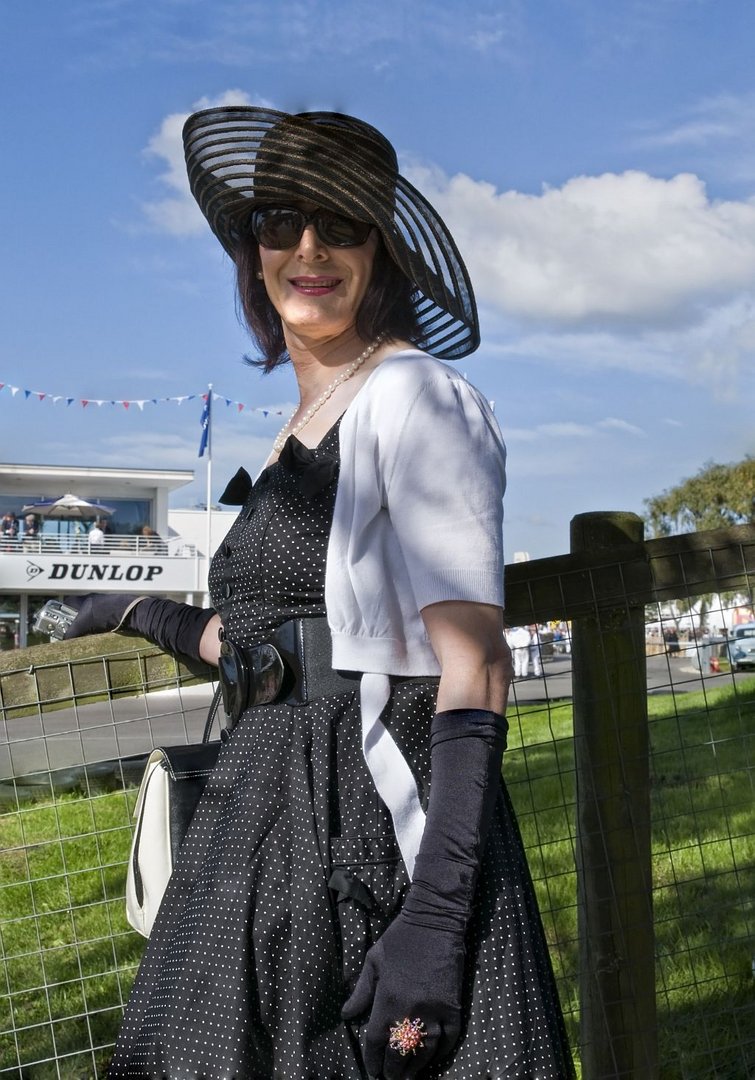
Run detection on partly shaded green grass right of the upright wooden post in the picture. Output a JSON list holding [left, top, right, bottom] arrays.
[[650, 680, 755, 1080]]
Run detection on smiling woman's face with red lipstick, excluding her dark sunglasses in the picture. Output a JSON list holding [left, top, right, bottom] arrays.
[[259, 203, 379, 341]]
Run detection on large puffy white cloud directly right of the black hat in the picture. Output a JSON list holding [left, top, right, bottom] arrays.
[[410, 165, 755, 329]]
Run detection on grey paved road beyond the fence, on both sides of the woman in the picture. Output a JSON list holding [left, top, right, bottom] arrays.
[[0, 656, 751, 785]]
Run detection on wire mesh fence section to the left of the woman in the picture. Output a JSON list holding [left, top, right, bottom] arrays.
[[0, 646, 217, 1080]]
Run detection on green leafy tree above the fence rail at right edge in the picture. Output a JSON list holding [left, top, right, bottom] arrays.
[[644, 455, 755, 536]]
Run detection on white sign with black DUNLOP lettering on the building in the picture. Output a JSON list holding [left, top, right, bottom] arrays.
[[0, 554, 199, 593]]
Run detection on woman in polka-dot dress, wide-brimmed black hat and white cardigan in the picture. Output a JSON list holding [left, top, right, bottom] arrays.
[[72, 107, 572, 1080]]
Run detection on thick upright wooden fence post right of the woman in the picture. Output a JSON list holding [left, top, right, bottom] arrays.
[[571, 513, 658, 1080]]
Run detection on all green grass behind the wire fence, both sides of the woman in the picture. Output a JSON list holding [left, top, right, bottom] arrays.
[[0, 680, 755, 1080]]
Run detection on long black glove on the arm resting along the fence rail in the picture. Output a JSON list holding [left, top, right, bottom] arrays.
[[65, 593, 215, 663]]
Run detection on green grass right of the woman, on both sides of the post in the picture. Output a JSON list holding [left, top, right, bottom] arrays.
[[503, 680, 755, 1080]]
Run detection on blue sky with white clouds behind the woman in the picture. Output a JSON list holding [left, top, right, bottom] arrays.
[[0, 0, 755, 558]]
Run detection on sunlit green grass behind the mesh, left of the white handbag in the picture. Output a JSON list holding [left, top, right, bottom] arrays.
[[0, 792, 144, 1080]]
